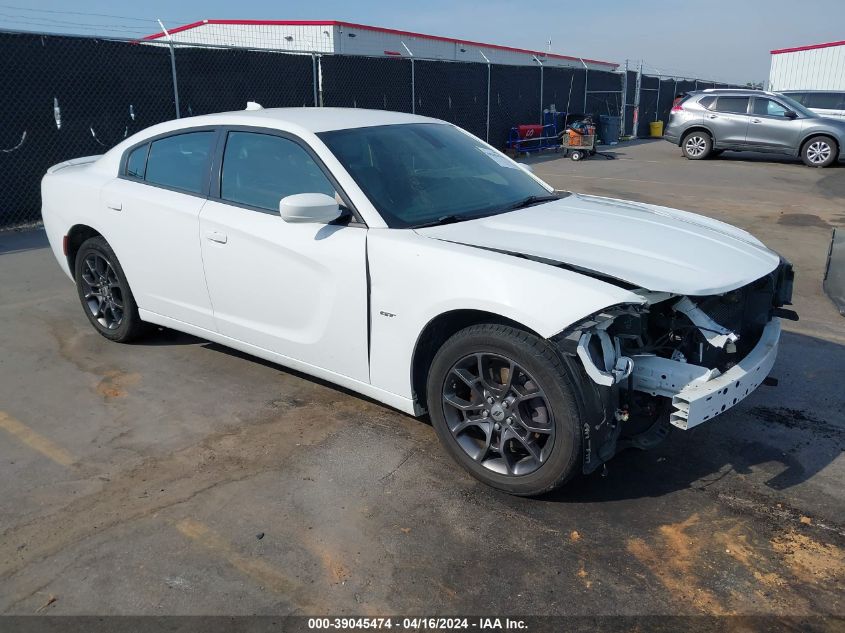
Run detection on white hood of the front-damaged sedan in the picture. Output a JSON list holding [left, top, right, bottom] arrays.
[[417, 194, 780, 295]]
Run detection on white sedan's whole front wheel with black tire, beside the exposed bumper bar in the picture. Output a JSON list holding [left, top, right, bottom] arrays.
[[427, 324, 582, 496]]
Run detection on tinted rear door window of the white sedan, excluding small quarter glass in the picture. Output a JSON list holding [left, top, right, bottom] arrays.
[[144, 130, 215, 193]]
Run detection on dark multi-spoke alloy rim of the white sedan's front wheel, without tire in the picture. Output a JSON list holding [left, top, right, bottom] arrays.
[[442, 353, 555, 476]]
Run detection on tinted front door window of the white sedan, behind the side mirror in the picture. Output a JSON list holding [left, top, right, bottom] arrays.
[[220, 132, 335, 212]]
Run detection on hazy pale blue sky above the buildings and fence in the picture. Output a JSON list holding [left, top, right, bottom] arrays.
[[0, 0, 845, 83]]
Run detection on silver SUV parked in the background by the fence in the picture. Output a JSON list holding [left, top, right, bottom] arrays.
[[663, 89, 845, 167]]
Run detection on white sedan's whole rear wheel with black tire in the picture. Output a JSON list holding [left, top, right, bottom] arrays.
[[74, 236, 147, 343]]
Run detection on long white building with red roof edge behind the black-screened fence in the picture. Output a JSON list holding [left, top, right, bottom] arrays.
[[144, 20, 619, 71]]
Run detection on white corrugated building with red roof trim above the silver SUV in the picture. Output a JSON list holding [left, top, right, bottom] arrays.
[[769, 41, 845, 92]]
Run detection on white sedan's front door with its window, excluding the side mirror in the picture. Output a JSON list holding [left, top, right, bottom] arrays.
[[200, 129, 369, 382]]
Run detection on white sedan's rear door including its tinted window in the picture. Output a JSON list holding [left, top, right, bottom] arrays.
[[100, 128, 217, 330]]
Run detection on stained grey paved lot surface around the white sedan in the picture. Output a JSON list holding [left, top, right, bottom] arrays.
[[0, 141, 845, 615]]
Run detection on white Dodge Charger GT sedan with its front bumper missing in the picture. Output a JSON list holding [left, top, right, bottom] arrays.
[[42, 106, 796, 495]]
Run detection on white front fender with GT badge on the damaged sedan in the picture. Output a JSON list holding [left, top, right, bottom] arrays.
[[367, 229, 644, 398]]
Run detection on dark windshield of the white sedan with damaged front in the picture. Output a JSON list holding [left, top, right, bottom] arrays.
[[318, 123, 552, 228]]
